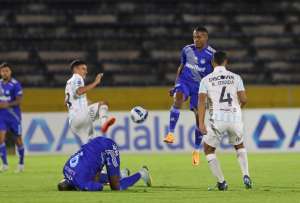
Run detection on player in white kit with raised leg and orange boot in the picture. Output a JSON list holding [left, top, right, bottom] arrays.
[[65, 60, 116, 143]]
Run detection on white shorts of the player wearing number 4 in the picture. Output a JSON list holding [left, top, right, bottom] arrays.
[[203, 120, 244, 148]]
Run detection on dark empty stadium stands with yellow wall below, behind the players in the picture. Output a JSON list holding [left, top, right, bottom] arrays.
[[0, 0, 300, 151]]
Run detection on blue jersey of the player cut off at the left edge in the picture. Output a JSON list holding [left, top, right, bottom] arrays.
[[0, 78, 23, 120]]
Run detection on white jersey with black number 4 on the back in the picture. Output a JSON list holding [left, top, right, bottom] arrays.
[[200, 66, 244, 122]]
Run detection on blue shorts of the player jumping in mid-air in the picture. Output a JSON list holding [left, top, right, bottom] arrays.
[[174, 79, 199, 110]]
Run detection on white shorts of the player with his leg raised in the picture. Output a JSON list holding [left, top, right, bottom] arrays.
[[69, 103, 99, 143]]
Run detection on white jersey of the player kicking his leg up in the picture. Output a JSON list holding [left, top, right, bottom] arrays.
[[65, 74, 88, 113]]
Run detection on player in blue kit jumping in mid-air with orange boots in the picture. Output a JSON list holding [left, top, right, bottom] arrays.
[[164, 27, 215, 165]]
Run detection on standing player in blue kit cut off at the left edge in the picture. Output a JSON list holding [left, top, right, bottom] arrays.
[[0, 63, 24, 172]]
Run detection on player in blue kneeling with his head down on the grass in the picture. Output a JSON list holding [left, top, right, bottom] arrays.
[[58, 137, 152, 191]]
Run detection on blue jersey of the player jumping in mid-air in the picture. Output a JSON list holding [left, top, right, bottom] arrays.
[[179, 44, 215, 87]]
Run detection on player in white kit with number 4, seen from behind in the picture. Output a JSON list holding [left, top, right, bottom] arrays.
[[198, 51, 252, 190]]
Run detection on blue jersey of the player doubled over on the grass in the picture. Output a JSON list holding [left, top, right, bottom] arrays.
[[63, 137, 120, 189]]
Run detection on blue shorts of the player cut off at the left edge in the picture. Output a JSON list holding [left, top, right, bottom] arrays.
[[0, 114, 22, 136]]
